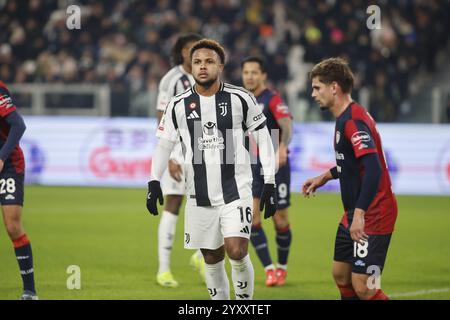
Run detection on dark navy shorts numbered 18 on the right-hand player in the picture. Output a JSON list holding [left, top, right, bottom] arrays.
[[334, 223, 392, 274]]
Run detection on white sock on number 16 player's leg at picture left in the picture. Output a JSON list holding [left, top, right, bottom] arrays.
[[205, 260, 230, 300]]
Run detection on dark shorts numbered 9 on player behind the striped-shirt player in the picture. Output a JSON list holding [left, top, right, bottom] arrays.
[[252, 158, 291, 209]]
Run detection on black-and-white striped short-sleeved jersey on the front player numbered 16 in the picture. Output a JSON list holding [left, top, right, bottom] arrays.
[[157, 83, 266, 206]]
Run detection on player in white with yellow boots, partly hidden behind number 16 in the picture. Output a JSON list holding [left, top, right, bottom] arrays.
[[156, 33, 205, 287]]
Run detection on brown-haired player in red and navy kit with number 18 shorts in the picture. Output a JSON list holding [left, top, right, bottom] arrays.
[[302, 58, 397, 300]]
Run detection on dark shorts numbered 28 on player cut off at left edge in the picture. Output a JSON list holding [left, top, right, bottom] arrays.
[[0, 172, 25, 206]]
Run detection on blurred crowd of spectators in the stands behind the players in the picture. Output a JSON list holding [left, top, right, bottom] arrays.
[[0, 0, 450, 121]]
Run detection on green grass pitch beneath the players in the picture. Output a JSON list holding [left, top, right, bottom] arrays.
[[0, 186, 450, 300]]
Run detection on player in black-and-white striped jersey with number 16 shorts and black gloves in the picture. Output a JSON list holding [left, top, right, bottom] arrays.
[[147, 39, 277, 299]]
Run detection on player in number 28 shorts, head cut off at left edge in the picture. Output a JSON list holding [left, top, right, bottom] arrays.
[[0, 81, 38, 300]]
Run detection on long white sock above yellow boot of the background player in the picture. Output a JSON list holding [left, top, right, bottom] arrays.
[[158, 211, 178, 273]]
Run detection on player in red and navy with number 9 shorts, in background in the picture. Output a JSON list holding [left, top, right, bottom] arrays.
[[241, 56, 292, 287]]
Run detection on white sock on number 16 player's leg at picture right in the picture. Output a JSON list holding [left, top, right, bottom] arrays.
[[230, 254, 255, 300]]
